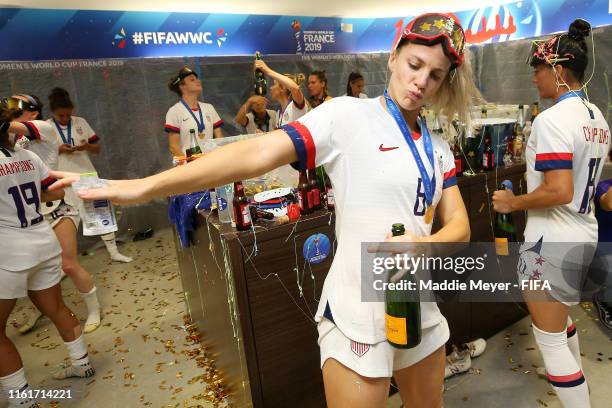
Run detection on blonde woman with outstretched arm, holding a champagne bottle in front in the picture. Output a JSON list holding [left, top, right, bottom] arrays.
[[51, 14, 477, 408]]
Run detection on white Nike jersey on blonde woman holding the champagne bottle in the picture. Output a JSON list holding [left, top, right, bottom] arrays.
[[283, 97, 456, 344]]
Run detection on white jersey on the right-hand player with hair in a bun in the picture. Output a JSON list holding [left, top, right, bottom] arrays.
[[525, 97, 610, 249]]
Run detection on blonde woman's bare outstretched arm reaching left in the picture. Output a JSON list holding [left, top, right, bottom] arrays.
[[50, 130, 297, 204]]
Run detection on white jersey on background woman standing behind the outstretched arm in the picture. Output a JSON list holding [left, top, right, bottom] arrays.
[[164, 101, 223, 153]]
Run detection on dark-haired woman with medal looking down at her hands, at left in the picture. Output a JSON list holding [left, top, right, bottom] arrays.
[[47, 88, 132, 262]]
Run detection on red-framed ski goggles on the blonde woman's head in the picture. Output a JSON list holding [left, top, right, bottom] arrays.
[[398, 13, 465, 69]]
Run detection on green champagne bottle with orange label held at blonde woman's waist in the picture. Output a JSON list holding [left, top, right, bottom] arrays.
[[385, 223, 421, 349]]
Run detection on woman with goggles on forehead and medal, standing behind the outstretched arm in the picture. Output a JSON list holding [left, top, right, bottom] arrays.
[[164, 67, 223, 156]]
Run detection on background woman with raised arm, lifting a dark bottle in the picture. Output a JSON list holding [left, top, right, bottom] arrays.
[[255, 60, 308, 127]]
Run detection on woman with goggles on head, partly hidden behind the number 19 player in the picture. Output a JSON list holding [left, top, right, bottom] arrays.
[[10, 95, 100, 333]]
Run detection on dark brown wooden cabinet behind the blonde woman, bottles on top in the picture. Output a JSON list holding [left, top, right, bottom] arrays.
[[177, 165, 525, 408]]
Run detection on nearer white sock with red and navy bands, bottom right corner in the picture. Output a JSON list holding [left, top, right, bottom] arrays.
[[533, 324, 591, 408]]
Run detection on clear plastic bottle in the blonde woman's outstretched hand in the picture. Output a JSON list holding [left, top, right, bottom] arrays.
[[72, 173, 117, 236]]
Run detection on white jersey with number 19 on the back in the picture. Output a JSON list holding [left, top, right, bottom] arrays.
[[0, 149, 61, 271]]
